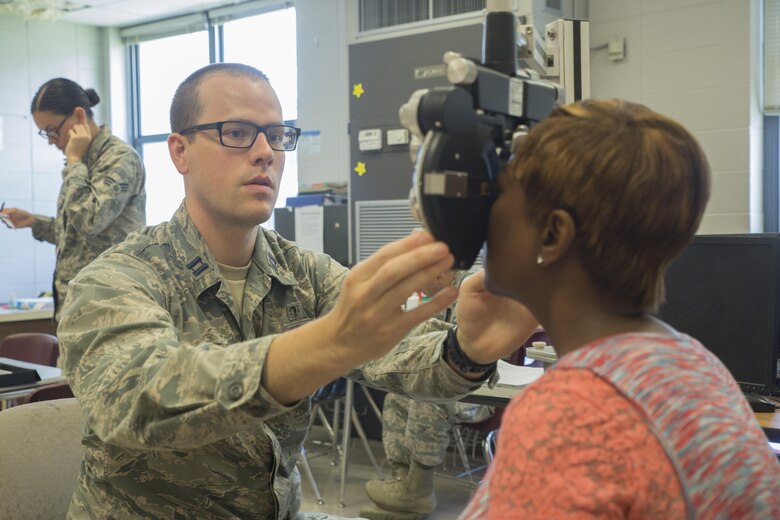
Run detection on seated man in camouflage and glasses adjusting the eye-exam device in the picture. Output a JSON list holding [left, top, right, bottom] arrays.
[[59, 64, 533, 520]]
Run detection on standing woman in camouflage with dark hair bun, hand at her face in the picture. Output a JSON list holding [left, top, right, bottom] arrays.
[[2, 78, 146, 319]]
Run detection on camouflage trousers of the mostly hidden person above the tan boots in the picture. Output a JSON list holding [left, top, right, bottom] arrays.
[[382, 394, 494, 466]]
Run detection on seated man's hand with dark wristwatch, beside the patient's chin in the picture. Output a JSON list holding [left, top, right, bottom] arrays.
[[455, 271, 539, 364]]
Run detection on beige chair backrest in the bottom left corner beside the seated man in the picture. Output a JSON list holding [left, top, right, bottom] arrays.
[[0, 399, 84, 520]]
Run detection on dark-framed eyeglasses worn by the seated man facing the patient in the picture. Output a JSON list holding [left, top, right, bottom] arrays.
[[179, 121, 301, 152]]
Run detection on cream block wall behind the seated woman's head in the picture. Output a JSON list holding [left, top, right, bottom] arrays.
[[590, 0, 763, 233]]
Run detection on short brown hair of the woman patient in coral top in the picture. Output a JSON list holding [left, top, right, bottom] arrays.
[[507, 100, 710, 312]]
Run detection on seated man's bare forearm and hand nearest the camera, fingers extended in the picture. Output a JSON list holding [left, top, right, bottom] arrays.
[[262, 232, 458, 404]]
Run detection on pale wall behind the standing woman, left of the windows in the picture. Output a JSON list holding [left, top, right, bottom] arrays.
[[0, 16, 108, 301]]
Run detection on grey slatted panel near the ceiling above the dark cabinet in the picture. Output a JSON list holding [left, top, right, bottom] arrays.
[[358, 0, 485, 32]]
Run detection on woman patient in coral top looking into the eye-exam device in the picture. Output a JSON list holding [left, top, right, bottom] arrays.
[[461, 100, 780, 519]]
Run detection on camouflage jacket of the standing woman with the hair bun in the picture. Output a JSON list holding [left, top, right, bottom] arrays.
[[32, 126, 146, 318]]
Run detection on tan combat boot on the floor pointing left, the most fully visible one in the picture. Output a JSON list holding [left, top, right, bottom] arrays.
[[366, 462, 436, 515]]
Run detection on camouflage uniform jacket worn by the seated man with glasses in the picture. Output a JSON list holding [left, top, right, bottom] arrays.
[[58, 205, 479, 519]]
